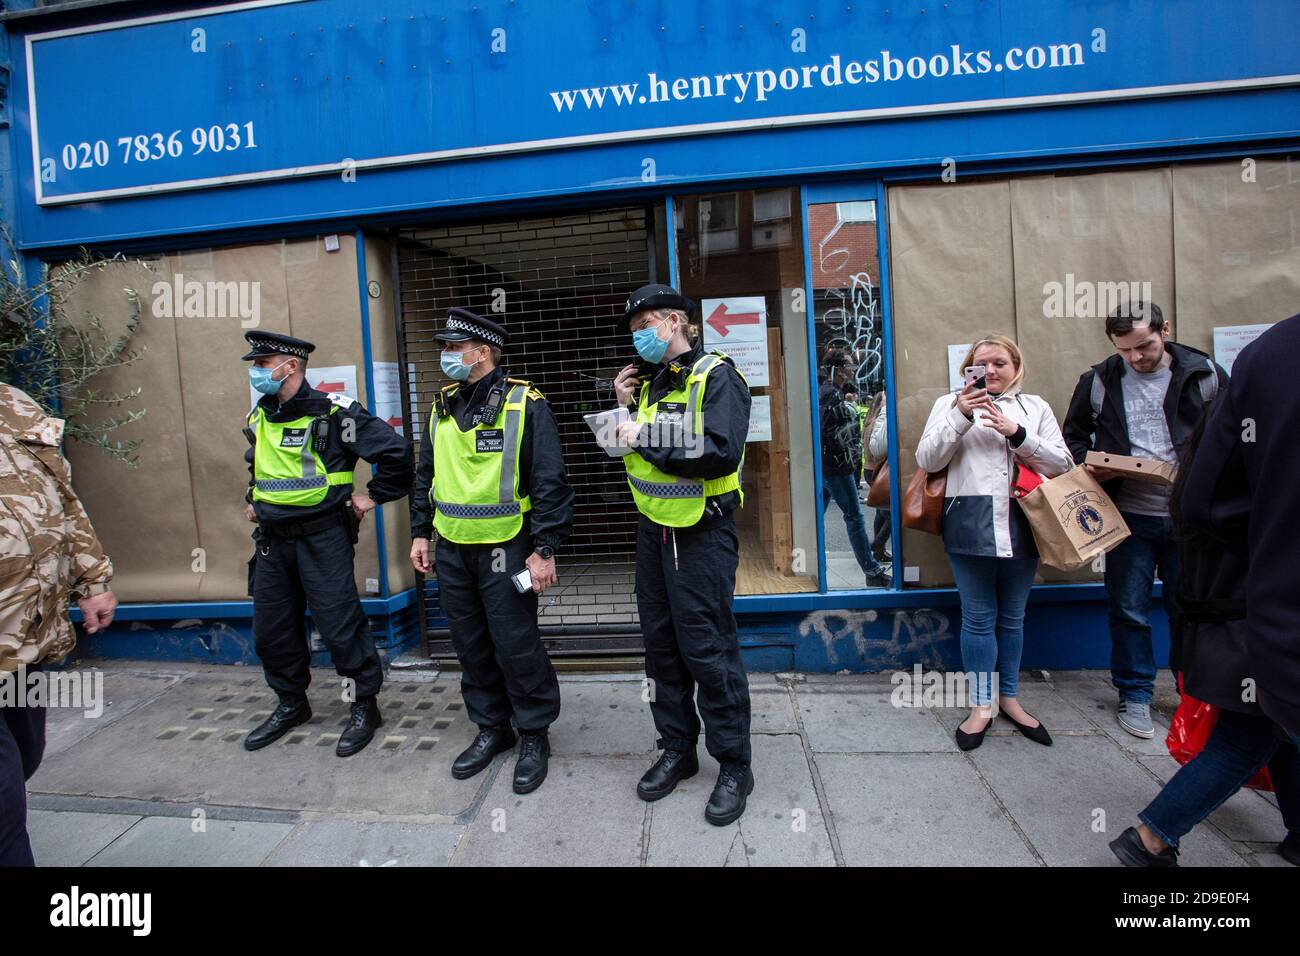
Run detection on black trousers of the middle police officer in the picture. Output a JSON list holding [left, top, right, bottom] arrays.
[[434, 531, 560, 731]]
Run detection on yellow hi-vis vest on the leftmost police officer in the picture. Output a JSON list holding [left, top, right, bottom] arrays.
[[248, 405, 352, 507]]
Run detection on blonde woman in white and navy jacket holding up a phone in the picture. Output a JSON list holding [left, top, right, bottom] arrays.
[[917, 333, 1074, 750]]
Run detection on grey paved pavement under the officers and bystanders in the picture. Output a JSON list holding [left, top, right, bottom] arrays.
[[30, 662, 1287, 866]]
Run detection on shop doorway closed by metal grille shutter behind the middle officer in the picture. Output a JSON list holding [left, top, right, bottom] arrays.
[[395, 206, 667, 658]]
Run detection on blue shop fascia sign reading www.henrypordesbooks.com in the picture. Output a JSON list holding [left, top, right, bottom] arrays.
[[10, 0, 1300, 239]]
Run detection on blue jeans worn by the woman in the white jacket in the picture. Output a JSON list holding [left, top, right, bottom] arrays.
[[948, 553, 1039, 706]]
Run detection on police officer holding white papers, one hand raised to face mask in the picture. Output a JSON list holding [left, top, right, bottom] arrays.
[[614, 285, 754, 826]]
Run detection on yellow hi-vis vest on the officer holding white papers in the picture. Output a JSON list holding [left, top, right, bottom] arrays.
[[623, 351, 745, 528]]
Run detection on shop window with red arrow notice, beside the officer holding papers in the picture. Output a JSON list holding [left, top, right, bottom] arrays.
[[675, 189, 818, 594]]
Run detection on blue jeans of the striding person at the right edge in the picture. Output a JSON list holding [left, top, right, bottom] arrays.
[[1138, 710, 1300, 847]]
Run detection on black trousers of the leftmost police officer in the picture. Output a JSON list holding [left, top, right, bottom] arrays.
[[252, 510, 384, 702]]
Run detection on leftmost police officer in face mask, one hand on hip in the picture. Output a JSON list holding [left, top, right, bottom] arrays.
[[243, 332, 412, 757]]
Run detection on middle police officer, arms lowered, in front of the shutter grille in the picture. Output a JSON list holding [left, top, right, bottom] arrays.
[[411, 308, 573, 793]]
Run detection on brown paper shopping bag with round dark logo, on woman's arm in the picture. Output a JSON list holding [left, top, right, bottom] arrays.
[[1019, 468, 1130, 571]]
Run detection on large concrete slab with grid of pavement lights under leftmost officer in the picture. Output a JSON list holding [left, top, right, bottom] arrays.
[[30, 669, 491, 817]]
